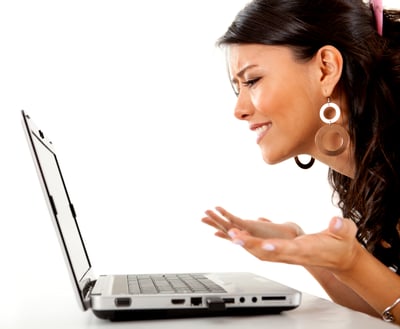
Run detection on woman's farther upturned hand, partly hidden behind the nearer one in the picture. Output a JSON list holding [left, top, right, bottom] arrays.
[[202, 207, 304, 240]]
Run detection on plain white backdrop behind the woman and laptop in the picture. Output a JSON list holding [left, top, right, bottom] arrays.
[[0, 0, 397, 322]]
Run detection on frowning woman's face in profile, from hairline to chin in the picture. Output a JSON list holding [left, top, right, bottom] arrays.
[[229, 44, 327, 164]]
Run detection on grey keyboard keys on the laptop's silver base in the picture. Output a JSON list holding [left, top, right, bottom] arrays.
[[128, 274, 226, 295]]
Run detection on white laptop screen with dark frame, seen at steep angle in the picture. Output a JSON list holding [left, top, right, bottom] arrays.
[[30, 130, 90, 282]]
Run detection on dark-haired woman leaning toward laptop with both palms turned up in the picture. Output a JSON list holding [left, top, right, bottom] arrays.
[[202, 0, 400, 323]]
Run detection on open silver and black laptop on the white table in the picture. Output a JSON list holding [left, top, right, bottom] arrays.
[[21, 111, 301, 321]]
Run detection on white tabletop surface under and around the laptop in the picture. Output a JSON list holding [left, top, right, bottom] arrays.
[[0, 294, 397, 329]]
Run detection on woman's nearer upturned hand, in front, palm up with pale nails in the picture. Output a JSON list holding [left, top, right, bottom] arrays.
[[228, 217, 361, 274]]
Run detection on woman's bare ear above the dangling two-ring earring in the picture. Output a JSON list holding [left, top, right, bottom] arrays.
[[316, 46, 343, 97]]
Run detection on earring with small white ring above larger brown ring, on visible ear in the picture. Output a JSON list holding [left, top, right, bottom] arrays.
[[315, 98, 350, 156]]
